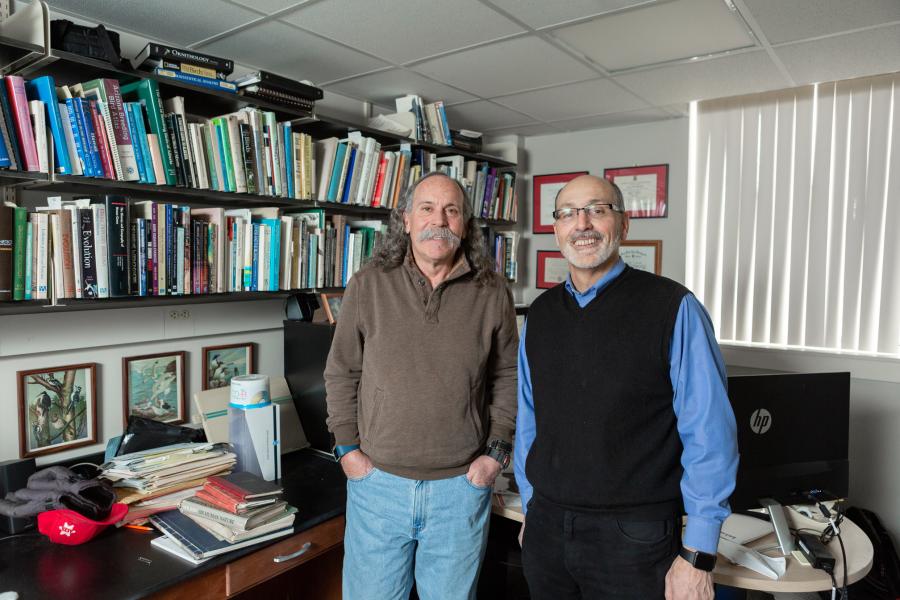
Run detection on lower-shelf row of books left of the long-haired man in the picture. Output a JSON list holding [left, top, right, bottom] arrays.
[[0, 196, 386, 301]]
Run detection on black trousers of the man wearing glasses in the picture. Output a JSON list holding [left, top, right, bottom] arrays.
[[522, 497, 681, 600]]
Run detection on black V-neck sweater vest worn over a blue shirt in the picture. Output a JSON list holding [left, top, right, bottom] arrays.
[[525, 266, 688, 517]]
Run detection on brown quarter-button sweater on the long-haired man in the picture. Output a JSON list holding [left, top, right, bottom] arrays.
[[325, 256, 518, 479]]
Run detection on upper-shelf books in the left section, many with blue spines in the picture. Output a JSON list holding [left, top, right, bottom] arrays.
[[0, 75, 315, 199]]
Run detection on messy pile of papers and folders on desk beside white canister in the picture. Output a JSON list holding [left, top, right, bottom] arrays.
[[100, 443, 236, 504]]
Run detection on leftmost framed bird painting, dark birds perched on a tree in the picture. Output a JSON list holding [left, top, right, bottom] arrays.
[[16, 363, 97, 458]]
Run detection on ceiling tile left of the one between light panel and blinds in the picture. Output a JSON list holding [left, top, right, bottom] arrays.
[[493, 79, 647, 121]]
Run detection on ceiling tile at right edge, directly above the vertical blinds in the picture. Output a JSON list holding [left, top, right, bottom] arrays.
[[775, 26, 900, 85]]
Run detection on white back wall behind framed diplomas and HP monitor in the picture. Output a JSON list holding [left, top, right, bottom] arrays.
[[515, 119, 900, 541]]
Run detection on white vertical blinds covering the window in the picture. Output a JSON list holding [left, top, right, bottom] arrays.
[[685, 74, 900, 357]]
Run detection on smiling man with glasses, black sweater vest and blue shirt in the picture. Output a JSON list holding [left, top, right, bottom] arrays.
[[514, 175, 738, 600]]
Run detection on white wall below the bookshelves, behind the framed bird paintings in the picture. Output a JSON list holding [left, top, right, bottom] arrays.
[[0, 300, 284, 464]]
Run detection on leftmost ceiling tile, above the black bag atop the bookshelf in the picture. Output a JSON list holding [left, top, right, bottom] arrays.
[[39, 0, 261, 46]]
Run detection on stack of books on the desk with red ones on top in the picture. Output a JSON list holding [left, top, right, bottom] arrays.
[[150, 471, 297, 561]]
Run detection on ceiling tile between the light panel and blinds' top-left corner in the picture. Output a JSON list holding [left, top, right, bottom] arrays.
[[615, 50, 792, 106]]
